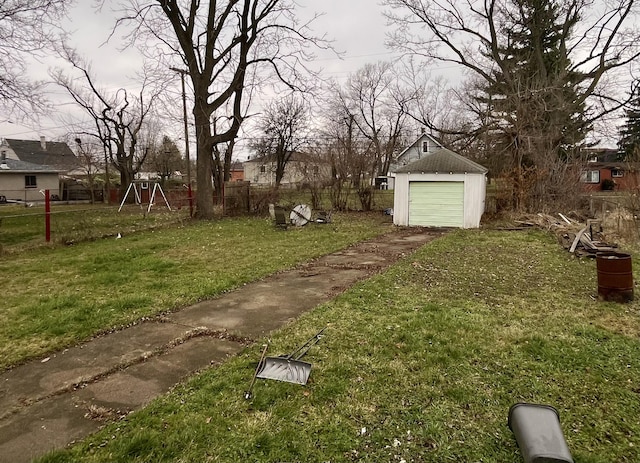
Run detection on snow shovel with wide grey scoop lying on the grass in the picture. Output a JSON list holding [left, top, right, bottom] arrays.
[[256, 328, 325, 385]]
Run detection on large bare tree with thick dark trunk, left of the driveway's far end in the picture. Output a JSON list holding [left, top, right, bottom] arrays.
[[108, 0, 328, 219]]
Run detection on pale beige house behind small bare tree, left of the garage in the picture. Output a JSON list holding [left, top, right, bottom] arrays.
[[244, 152, 331, 187]]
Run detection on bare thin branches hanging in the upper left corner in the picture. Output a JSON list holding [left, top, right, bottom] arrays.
[[0, 0, 72, 117]]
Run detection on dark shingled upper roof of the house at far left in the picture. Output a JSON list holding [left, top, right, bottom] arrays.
[[5, 138, 81, 172]]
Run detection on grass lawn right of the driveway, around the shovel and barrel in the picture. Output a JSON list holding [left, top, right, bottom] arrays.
[[40, 231, 640, 463]]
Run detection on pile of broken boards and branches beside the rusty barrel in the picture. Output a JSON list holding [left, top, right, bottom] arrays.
[[508, 214, 618, 257]]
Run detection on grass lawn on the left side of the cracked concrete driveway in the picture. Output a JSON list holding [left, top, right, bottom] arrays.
[[0, 214, 392, 368]]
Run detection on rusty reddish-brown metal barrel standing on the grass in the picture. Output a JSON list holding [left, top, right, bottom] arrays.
[[596, 252, 633, 302]]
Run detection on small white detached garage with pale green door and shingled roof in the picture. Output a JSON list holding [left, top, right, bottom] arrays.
[[393, 148, 487, 228]]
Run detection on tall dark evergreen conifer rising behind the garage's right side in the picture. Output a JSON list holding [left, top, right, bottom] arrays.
[[476, 0, 590, 208]]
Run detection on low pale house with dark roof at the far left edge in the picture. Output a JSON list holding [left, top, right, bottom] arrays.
[[0, 137, 83, 201]]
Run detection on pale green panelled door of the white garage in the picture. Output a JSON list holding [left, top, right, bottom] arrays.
[[409, 182, 464, 227]]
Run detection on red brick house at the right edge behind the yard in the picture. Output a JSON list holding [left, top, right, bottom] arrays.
[[580, 148, 640, 192]]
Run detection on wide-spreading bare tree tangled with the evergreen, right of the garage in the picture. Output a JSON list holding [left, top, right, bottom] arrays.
[[384, 0, 640, 212]]
